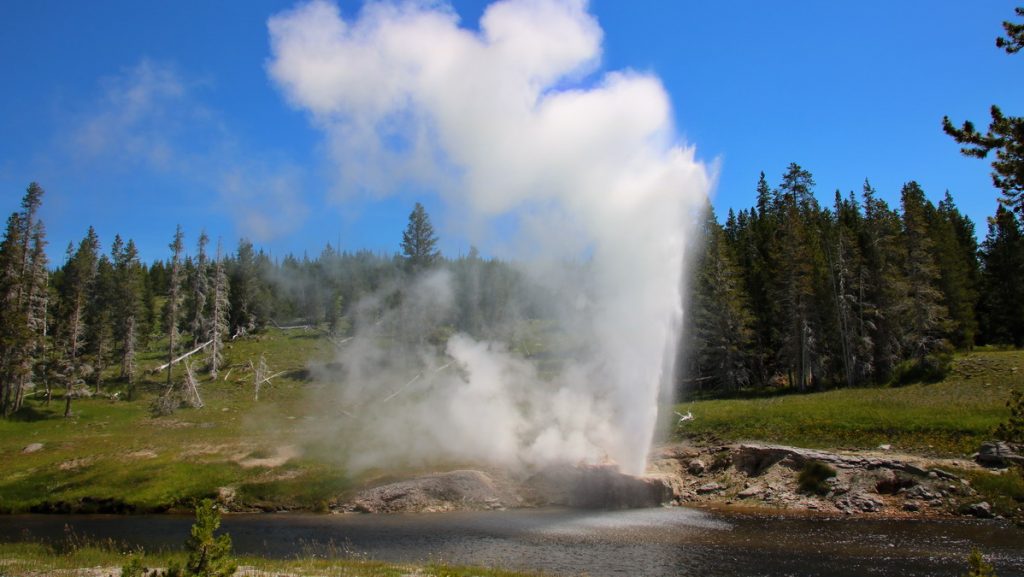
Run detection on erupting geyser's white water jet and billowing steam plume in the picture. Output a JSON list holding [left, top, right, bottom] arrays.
[[268, 0, 711, 473]]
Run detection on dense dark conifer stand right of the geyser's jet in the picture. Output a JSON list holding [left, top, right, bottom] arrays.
[[683, 163, 1024, 394]]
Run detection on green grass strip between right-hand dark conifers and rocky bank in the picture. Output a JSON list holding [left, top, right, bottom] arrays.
[[675, 351, 1024, 456]]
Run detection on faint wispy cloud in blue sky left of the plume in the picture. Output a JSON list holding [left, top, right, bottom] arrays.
[[62, 59, 309, 241]]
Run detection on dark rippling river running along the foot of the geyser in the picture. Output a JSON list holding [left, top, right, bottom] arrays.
[[0, 507, 1024, 577]]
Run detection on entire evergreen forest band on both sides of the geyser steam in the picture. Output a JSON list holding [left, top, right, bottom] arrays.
[[0, 164, 1024, 414]]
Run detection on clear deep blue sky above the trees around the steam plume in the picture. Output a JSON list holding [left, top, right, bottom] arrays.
[[0, 0, 1024, 260]]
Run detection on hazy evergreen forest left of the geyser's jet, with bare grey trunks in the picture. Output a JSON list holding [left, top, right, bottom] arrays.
[[0, 192, 541, 416]]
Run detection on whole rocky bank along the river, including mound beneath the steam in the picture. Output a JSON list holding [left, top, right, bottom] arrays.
[[334, 443, 1024, 518]]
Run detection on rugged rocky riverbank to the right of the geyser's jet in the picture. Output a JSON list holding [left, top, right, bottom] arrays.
[[648, 444, 992, 518]]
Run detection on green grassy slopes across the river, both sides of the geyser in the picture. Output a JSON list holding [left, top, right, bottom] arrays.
[[0, 330, 1024, 512]]
